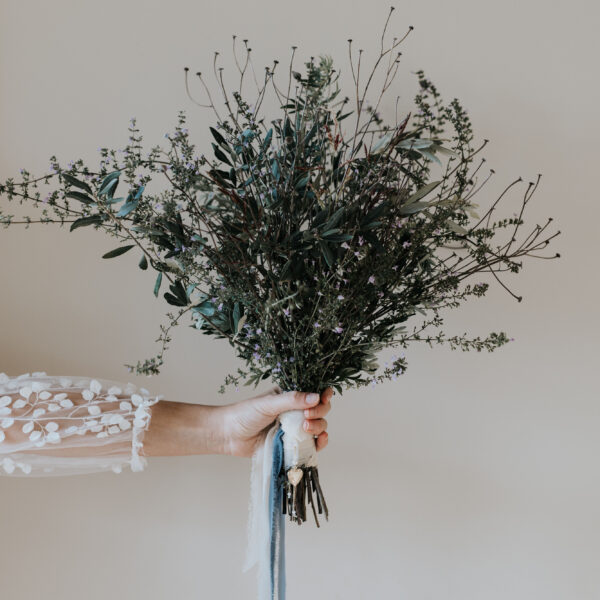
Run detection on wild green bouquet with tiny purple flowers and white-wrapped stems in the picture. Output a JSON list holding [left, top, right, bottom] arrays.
[[0, 9, 559, 595]]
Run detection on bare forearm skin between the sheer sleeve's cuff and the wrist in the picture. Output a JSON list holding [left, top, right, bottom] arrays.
[[144, 400, 225, 456]]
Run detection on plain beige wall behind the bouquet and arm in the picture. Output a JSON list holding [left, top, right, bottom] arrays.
[[0, 0, 600, 600]]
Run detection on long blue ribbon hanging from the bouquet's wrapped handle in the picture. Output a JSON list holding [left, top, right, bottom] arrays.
[[269, 428, 285, 600]]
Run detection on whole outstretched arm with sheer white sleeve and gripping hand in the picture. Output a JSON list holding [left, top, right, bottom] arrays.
[[0, 373, 331, 475]]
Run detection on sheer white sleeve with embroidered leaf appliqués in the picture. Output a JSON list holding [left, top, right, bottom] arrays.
[[0, 372, 162, 476]]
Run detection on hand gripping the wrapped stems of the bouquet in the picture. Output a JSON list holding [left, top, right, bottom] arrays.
[[222, 387, 333, 457]]
